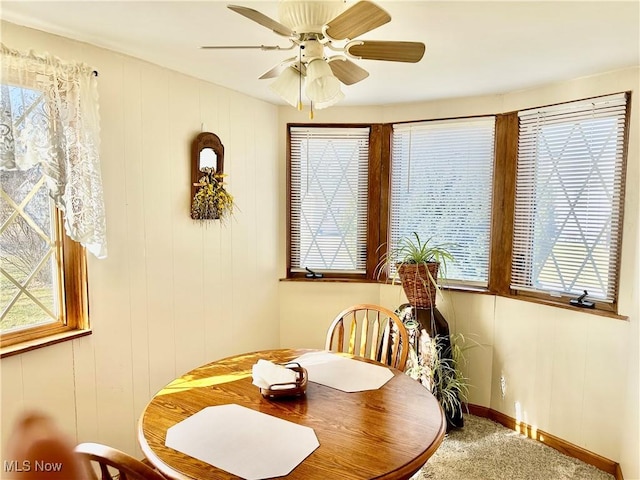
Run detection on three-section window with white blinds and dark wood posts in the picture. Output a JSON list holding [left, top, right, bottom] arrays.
[[287, 93, 630, 316]]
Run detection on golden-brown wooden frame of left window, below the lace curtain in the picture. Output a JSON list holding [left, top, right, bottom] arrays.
[[0, 208, 90, 350]]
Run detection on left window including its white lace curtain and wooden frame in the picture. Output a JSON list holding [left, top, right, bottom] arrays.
[[0, 45, 106, 350]]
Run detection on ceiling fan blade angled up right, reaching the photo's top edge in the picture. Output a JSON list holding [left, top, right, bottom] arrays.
[[325, 0, 391, 40]]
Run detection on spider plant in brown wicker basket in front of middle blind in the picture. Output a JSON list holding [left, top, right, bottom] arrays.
[[378, 232, 453, 308]]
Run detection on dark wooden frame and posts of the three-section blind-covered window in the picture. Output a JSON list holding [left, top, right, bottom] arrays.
[[286, 92, 631, 319]]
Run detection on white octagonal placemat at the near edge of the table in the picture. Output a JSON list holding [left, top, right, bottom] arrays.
[[165, 404, 320, 480]]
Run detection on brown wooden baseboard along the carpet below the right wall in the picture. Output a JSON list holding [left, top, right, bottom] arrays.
[[467, 404, 624, 480]]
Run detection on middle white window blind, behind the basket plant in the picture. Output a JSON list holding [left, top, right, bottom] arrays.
[[390, 116, 495, 286]]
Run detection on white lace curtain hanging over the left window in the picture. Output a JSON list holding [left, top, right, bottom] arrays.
[[0, 45, 107, 258]]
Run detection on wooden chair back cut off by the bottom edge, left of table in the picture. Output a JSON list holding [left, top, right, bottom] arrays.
[[75, 443, 167, 480]]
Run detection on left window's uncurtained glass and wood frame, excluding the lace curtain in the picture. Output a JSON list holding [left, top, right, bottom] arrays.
[[0, 85, 86, 346]]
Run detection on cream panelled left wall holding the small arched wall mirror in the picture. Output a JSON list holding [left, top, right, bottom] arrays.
[[0, 23, 279, 456]]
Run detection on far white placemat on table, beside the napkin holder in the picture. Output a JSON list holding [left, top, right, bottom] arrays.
[[294, 352, 393, 392]]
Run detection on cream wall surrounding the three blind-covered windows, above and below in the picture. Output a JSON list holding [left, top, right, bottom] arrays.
[[279, 68, 640, 479]]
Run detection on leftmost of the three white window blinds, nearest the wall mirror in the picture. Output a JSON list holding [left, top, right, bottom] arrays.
[[289, 126, 369, 273]]
